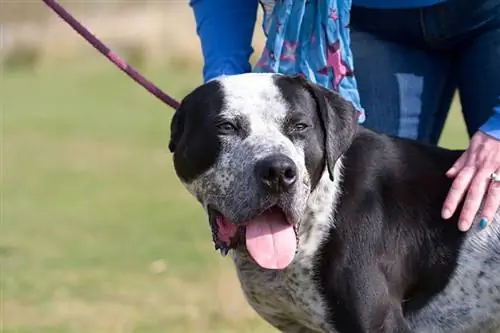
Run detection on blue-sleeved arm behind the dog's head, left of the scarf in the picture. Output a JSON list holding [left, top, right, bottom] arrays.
[[189, 0, 258, 82]]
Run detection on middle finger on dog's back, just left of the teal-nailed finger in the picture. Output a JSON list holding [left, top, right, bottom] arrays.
[[458, 169, 491, 231]]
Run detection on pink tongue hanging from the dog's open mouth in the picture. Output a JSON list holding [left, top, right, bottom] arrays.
[[246, 210, 297, 269]]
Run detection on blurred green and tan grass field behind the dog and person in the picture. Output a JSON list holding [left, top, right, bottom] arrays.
[[0, 0, 467, 333]]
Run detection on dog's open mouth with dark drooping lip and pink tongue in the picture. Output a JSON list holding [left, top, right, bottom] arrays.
[[208, 205, 298, 269]]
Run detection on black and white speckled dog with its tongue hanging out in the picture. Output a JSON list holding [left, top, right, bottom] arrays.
[[169, 74, 500, 333]]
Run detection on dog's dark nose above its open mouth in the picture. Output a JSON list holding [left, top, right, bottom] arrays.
[[255, 155, 297, 193]]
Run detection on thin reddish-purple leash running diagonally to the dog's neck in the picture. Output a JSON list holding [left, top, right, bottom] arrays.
[[42, 0, 179, 110]]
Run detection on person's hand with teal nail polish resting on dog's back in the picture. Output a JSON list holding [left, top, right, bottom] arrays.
[[441, 132, 500, 231]]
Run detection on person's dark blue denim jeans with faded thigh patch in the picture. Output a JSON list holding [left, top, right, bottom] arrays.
[[351, 0, 500, 144]]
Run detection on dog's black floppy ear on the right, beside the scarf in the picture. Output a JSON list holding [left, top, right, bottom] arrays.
[[294, 76, 358, 180]]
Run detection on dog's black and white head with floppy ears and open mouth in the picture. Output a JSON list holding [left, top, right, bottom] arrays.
[[169, 74, 357, 268]]
